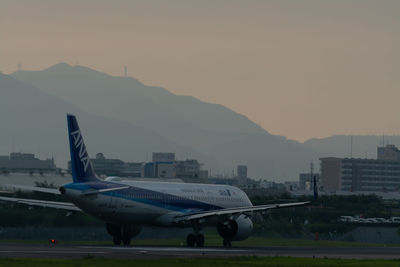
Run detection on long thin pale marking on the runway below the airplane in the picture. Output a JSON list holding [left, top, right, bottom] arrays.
[[80, 246, 249, 252]]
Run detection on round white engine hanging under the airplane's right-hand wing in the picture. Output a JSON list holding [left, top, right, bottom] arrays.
[[217, 214, 253, 241]]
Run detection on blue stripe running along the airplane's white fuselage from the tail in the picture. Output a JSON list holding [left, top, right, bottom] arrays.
[[64, 181, 222, 213]]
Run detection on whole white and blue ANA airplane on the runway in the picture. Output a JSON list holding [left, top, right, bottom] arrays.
[[0, 114, 311, 247]]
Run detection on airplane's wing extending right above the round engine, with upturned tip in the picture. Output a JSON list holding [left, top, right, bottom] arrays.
[[175, 201, 311, 222]]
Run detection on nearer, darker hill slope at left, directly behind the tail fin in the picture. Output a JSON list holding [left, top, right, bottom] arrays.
[[0, 74, 209, 170]]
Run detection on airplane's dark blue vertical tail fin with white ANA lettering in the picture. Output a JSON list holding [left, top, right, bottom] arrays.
[[67, 114, 97, 183]]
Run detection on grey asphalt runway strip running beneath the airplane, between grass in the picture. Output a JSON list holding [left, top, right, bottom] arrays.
[[0, 244, 400, 259]]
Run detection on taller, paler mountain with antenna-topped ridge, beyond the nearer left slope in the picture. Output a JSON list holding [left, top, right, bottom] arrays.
[[12, 63, 318, 181]]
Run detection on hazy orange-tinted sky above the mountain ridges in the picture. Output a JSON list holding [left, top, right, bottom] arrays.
[[0, 0, 400, 140]]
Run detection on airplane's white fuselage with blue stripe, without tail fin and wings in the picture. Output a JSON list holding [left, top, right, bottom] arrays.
[[65, 180, 252, 226]]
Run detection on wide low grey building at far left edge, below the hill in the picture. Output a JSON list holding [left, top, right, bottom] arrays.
[[0, 152, 57, 173]]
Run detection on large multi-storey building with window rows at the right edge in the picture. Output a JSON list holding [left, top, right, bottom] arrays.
[[320, 145, 400, 192]]
